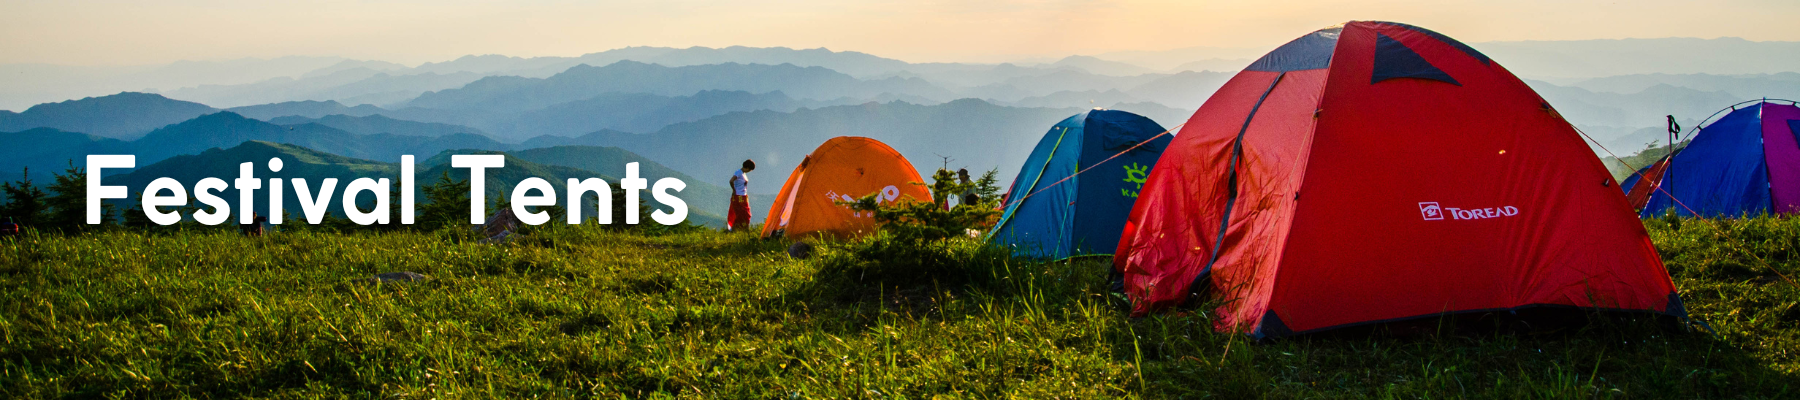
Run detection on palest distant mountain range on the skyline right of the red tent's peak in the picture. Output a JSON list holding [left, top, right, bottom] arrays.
[[1476, 34, 1800, 79]]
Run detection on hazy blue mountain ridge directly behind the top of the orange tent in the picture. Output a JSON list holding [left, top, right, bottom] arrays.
[[547, 99, 1108, 188]]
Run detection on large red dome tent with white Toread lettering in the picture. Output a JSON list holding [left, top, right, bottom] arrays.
[[1114, 22, 1685, 337]]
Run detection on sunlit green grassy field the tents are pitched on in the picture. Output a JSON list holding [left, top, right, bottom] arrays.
[[0, 218, 1800, 398]]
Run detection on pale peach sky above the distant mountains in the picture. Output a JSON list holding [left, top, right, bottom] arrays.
[[0, 0, 1800, 65]]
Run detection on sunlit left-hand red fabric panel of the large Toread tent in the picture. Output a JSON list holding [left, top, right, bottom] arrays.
[[1114, 68, 1325, 315]]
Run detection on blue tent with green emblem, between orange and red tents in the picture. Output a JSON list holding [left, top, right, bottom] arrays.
[[988, 110, 1174, 259]]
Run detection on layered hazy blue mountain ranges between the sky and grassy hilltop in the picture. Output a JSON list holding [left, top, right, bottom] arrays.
[[0, 38, 1800, 225]]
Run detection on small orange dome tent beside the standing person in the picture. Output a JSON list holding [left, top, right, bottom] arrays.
[[763, 137, 931, 238]]
